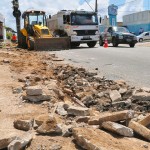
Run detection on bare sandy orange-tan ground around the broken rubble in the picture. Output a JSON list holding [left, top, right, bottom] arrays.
[[0, 44, 150, 150]]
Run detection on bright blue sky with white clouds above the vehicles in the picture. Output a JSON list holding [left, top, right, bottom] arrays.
[[0, 0, 150, 30]]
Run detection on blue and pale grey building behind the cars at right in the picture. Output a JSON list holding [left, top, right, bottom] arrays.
[[123, 10, 150, 35]]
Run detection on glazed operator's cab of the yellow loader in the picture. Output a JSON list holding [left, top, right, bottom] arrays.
[[22, 10, 46, 36]]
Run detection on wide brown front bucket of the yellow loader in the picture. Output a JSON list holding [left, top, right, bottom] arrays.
[[34, 37, 70, 51]]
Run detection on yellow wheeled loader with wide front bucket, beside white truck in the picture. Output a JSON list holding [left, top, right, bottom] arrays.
[[19, 10, 70, 50]]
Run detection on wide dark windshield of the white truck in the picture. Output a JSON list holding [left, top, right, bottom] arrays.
[[71, 14, 98, 25]]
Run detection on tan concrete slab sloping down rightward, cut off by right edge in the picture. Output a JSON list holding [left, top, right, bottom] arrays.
[[128, 121, 150, 141]]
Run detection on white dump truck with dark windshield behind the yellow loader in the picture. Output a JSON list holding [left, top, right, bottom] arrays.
[[47, 10, 99, 48]]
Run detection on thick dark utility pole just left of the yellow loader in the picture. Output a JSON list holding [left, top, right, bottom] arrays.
[[12, 0, 21, 47]]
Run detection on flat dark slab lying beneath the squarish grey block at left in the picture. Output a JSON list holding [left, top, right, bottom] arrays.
[[22, 95, 51, 103]]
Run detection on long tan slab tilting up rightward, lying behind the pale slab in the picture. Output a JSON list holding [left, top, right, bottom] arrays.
[[88, 110, 134, 126]]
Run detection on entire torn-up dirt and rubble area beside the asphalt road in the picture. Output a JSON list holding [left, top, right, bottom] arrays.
[[0, 47, 150, 150]]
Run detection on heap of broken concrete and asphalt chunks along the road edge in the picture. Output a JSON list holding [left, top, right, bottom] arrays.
[[0, 50, 150, 150]]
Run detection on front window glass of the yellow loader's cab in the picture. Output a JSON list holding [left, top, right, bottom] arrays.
[[29, 13, 45, 26]]
